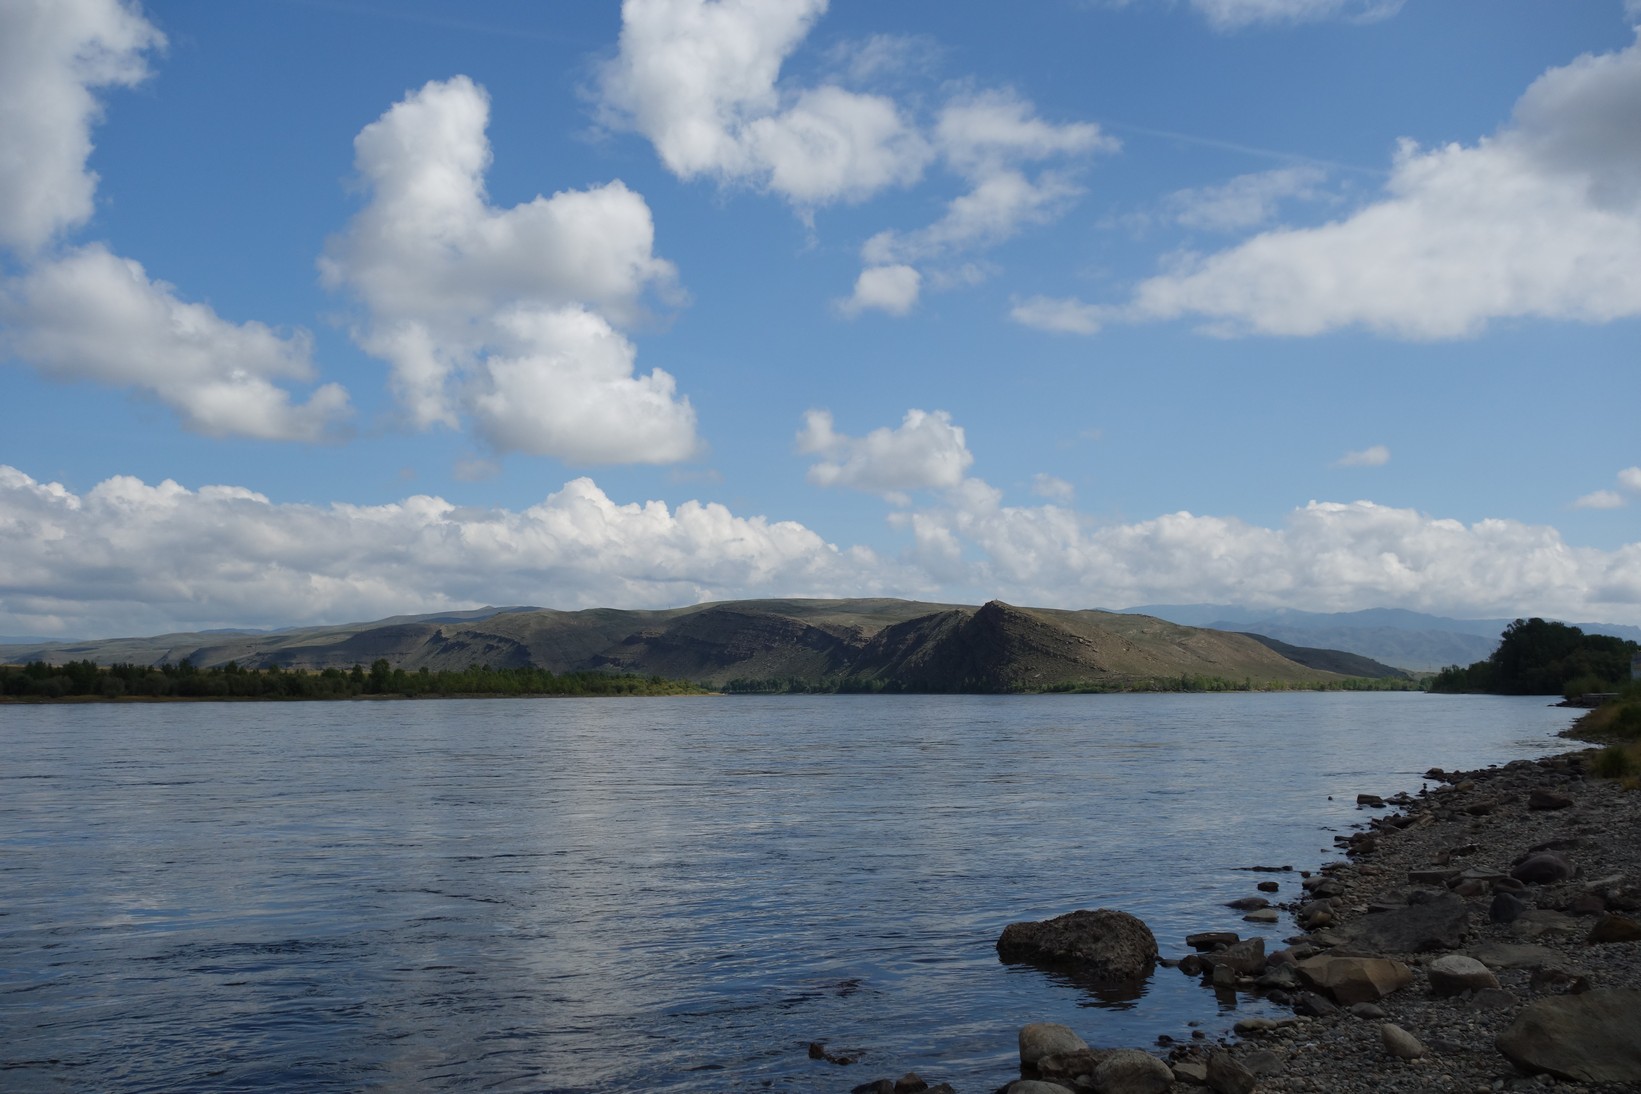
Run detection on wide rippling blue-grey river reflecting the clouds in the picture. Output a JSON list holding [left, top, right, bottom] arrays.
[[0, 694, 1572, 1094]]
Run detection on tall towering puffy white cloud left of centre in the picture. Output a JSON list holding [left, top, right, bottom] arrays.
[[320, 75, 699, 464]]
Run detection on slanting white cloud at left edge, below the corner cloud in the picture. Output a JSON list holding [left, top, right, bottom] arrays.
[[0, 244, 350, 441]]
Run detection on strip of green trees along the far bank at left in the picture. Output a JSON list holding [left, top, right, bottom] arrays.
[[0, 658, 704, 700]]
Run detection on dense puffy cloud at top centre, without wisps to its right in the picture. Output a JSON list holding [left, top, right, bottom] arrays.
[[602, 0, 929, 208]]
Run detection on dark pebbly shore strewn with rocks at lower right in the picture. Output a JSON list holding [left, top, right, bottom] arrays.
[[853, 750, 1641, 1094]]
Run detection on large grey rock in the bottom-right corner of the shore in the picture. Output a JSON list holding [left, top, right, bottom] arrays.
[[1497, 989, 1641, 1083]]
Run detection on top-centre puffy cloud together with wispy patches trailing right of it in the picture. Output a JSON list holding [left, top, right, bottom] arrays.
[[601, 0, 1116, 315]]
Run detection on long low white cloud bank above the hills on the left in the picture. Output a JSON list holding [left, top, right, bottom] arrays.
[[0, 466, 916, 635]]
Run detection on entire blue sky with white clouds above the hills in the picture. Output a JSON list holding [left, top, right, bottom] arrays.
[[0, 0, 1641, 638]]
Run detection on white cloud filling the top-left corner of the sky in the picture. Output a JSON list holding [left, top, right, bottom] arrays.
[[0, 0, 166, 254]]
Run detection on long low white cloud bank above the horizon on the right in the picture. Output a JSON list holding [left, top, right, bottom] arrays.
[[896, 481, 1641, 622]]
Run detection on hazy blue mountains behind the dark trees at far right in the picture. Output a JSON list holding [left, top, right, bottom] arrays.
[[1124, 604, 1641, 672]]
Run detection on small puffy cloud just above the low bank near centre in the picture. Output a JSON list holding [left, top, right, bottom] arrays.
[[798, 410, 975, 500]]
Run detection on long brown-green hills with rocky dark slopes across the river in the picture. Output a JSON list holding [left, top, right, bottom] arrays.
[[0, 600, 1398, 692]]
